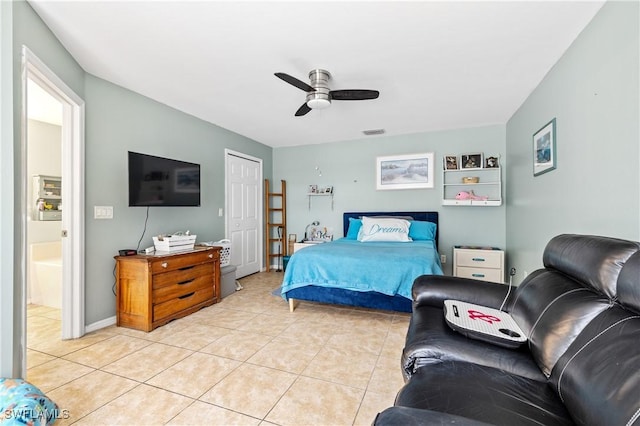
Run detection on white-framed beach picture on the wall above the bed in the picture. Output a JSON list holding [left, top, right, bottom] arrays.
[[376, 152, 434, 190]]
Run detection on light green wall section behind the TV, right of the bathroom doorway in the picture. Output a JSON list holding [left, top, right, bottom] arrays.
[[85, 75, 272, 324]]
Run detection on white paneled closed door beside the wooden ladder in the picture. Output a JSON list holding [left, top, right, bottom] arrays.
[[225, 150, 262, 278]]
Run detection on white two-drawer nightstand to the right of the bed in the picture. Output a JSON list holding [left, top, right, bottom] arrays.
[[453, 246, 504, 283]]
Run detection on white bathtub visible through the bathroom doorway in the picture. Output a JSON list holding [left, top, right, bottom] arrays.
[[27, 241, 62, 309]]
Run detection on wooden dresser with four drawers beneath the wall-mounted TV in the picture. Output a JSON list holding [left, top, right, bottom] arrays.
[[115, 247, 220, 331]]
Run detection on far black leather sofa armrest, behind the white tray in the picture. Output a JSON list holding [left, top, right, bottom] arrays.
[[412, 275, 513, 309]]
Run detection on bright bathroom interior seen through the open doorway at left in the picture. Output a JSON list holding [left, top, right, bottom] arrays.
[[25, 78, 64, 356]]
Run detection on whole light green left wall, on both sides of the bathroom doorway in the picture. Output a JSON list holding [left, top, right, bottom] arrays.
[[0, 0, 272, 377]]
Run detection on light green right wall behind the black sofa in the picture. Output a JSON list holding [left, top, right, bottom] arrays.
[[506, 1, 640, 282]]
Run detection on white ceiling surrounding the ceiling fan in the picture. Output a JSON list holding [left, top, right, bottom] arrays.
[[30, 0, 603, 147]]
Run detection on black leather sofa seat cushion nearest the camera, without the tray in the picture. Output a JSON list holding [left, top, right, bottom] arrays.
[[395, 361, 574, 426]]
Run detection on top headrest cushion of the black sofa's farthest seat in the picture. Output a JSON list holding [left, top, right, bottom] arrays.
[[542, 234, 640, 299]]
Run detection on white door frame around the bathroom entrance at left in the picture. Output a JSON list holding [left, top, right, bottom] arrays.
[[20, 46, 84, 370]]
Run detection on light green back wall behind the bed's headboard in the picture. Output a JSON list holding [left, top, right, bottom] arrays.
[[273, 125, 506, 272]]
